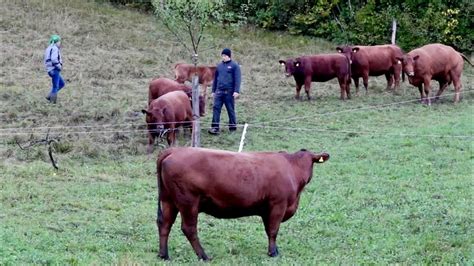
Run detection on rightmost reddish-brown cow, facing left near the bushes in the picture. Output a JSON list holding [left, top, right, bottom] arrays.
[[398, 43, 472, 105]]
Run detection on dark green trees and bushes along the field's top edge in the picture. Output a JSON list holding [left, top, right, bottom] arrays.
[[102, 0, 474, 52]]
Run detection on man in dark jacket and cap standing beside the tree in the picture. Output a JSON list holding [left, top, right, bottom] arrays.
[[208, 48, 241, 135]]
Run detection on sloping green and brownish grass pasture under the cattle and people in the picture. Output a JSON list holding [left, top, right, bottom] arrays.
[[0, 0, 474, 265]]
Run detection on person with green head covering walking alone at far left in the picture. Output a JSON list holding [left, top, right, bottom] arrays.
[[44, 34, 65, 103]]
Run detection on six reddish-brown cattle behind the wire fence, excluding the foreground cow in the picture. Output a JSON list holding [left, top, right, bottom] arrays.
[[142, 44, 472, 153]]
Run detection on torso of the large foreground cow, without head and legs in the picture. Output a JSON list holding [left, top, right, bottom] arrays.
[[161, 148, 296, 213]]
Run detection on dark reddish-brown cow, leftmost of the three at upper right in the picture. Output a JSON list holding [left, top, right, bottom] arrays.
[[279, 54, 351, 100]]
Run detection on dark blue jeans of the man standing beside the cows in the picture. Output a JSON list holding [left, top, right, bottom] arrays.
[[211, 90, 237, 131]]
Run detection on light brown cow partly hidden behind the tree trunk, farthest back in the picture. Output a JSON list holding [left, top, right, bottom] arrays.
[[174, 63, 216, 98]]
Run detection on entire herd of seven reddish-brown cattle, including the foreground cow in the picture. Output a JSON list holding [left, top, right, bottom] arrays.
[[143, 41, 472, 260]]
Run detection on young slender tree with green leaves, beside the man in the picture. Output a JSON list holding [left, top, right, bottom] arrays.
[[153, 0, 224, 147]]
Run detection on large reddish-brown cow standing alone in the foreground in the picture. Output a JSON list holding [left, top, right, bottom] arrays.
[[156, 148, 329, 260]]
